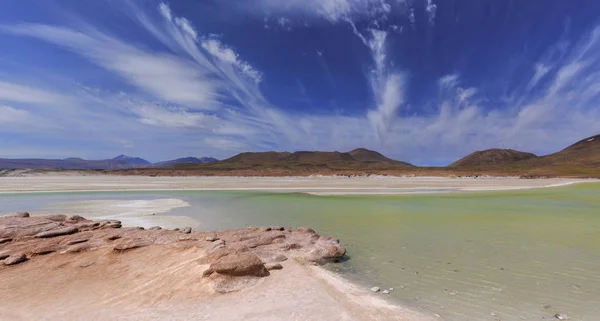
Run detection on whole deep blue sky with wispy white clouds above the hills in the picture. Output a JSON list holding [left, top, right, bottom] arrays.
[[0, 0, 600, 165]]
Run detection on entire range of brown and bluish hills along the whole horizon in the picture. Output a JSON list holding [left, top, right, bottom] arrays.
[[0, 135, 600, 177]]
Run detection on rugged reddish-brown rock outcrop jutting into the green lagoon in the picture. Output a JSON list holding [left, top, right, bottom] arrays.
[[0, 213, 346, 293]]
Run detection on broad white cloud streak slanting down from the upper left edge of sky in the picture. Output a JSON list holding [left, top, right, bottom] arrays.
[[4, 24, 218, 109]]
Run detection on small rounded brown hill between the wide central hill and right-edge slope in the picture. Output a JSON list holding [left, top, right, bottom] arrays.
[[448, 148, 537, 168]]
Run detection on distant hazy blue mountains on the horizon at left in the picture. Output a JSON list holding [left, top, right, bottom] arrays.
[[0, 155, 217, 170]]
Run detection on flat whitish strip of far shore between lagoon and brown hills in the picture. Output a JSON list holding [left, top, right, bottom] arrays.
[[0, 175, 599, 194]]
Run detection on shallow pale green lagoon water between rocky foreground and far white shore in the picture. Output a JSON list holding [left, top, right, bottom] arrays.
[[0, 184, 600, 320]]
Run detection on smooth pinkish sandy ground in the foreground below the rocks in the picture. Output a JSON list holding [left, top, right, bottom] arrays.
[[0, 242, 437, 321]]
